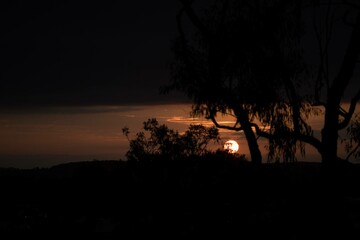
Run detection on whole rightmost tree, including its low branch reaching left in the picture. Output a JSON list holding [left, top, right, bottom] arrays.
[[276, 0, 360, 165]]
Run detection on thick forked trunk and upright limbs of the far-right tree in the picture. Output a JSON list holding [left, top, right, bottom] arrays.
[[315, 1, 360, 163]]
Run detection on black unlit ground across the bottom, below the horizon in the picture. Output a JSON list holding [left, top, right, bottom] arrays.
[[0, 158, 360, 239]]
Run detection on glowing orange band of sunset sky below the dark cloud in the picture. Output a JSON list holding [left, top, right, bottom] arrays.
[[0, 104, 321, 168]]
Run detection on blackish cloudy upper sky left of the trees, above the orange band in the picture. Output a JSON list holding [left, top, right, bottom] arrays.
[[0, 0, 186, 106]]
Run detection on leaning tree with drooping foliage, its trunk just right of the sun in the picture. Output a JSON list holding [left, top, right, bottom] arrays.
[[164, 0, 309, 165]]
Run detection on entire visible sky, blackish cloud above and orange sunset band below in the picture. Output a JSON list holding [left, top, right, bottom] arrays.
[[0, 0, 359, 168]]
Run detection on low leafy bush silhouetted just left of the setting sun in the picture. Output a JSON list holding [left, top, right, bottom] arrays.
[[123, 118, 220, 161]]
